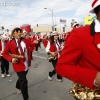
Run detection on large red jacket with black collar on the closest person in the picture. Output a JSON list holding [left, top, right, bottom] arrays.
[[56, 24, 100, 88]]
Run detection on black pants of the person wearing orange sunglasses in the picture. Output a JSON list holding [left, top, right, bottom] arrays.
[[16, 71, 29, 100]]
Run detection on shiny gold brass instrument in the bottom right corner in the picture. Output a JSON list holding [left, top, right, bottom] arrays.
[[69, 83, 100, 100]]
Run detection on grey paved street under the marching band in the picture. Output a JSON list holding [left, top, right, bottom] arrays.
[[0, 44, 74, 100]]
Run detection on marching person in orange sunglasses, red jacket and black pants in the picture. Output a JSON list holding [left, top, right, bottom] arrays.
[[3, 28, 34, 100]]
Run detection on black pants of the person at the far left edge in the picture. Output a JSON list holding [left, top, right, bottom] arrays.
[[1, 57, 9, 74]]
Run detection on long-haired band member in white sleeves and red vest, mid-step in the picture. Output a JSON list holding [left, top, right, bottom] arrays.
[[46, 31, 62, 82]]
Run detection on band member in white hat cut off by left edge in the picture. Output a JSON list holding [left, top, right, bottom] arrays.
[[0, 33, 10, 78]]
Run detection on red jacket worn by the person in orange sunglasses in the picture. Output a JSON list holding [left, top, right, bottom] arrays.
[[3, 39, 32, 72]]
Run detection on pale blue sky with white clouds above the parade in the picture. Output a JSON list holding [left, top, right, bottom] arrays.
[[0, 0, 93, 28]]
